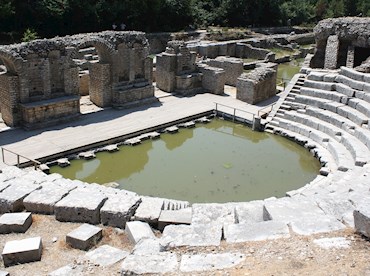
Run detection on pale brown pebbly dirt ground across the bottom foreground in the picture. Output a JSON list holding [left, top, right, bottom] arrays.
[[0, 215, 370, 276]]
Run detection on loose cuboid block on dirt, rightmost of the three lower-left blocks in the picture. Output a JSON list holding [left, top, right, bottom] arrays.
[[66, 223, 103, 250]]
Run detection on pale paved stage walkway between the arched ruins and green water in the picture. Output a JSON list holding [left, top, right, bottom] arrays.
[[0, 87, 278, 166]]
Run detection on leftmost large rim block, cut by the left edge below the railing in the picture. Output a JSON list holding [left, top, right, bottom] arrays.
[[0, 178, 41, 213]]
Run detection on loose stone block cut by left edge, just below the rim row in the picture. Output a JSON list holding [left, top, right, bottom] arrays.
[[0, 213, 32, 234]]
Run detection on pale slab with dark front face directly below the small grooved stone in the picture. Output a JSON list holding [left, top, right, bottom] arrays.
[[158, 208, 192, 231]]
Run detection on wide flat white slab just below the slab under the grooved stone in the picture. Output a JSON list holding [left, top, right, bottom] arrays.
[[161, 224, 222, 247]]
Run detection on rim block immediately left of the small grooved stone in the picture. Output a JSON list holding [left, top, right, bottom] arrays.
[[134, 197, 164, 224]]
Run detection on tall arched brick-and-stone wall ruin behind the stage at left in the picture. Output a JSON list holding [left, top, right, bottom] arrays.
[[0, 31, 155, 128]]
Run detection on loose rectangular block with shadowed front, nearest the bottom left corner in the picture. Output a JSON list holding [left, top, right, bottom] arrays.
[[1, 237, 42, 266]]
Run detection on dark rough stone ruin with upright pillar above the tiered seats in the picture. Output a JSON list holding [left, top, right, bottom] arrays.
[[311, 17, 370, 69]]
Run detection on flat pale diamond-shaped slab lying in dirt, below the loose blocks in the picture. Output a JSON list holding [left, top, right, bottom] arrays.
[[85, 245, 129, 266]]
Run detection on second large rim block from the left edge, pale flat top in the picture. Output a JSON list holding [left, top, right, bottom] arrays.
[[23, 182, 76, 214]]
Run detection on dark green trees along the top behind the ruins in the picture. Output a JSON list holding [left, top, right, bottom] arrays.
[[0, 0, 370, 40]]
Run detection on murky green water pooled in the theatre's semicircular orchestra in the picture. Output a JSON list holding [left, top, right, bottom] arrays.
[[51, 119, 320, 203]]
